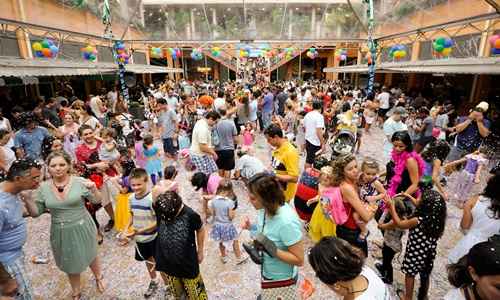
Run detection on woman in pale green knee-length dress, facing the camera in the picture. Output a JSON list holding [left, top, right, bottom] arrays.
[[25, 152, 104, 299]]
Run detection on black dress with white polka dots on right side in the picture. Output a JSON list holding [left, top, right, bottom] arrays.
[[401, 217, 438, 276]]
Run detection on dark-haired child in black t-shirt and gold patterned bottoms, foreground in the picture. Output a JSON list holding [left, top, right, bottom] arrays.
[[154, 191, 208, 299]]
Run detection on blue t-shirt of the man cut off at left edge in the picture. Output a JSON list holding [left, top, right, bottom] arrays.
[[0, 191, 27, 264]]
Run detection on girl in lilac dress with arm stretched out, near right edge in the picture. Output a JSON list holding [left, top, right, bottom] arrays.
[[444, 147, 488, 208]]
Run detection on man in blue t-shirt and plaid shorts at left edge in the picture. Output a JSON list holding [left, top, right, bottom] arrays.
[[0, 159, 41, 300]]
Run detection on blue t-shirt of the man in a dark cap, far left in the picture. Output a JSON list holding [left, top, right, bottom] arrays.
[[14, 126, 50, 159]]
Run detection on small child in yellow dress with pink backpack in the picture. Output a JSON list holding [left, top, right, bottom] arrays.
[[307, 166, 347, 243]]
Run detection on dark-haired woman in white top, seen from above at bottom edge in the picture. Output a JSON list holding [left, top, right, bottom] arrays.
[[309, 237, 391, 300]]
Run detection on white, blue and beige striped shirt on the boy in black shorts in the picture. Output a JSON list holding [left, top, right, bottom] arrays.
[[129, 193, 156, 243]]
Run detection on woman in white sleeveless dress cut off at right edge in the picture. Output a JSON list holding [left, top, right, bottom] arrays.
[[448, 174, 500, 263]]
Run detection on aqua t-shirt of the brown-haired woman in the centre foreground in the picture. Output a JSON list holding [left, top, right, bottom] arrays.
[[257, 203, 302, 280]]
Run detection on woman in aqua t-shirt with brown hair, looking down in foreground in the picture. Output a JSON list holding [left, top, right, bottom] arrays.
[[244, 173, 304, 300]]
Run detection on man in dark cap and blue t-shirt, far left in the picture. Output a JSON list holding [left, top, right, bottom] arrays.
[[14, 112, 50, 160]]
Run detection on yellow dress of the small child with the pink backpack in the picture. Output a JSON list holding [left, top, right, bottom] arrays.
[[309, 197, 337, 243]]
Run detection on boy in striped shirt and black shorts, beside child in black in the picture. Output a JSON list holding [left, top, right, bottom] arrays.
[[122, 168, 158, 298]]
